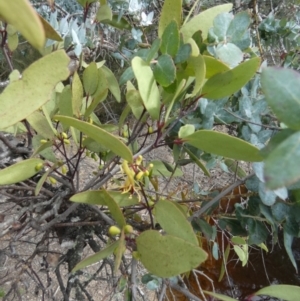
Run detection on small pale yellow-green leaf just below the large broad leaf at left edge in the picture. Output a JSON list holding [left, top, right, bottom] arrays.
[[26, 111, 55, 140]]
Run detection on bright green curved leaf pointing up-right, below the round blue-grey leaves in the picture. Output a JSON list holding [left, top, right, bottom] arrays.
[[201, 57, 260, 99]]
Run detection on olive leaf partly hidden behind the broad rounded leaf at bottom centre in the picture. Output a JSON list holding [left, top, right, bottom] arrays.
[[154, 200, 198, 246]]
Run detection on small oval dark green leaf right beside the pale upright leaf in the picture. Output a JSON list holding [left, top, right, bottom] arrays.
[[153, 54, 176, 87]]
